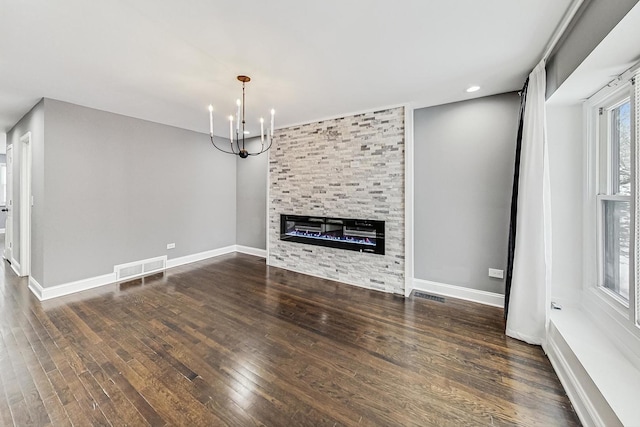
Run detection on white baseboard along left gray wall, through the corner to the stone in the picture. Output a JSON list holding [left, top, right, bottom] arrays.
[[26, 245, 266, 301]]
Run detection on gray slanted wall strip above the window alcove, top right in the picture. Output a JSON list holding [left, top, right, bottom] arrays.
[[546, 0, 638, 99]]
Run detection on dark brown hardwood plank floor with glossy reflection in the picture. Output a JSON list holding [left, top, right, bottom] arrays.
[[0, 249, 579, 426]]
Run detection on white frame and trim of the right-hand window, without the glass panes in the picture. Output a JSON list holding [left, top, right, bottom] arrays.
[[582, 70, 640, 360]]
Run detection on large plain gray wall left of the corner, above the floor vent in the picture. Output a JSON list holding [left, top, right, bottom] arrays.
[[41, 99, 236, 287]]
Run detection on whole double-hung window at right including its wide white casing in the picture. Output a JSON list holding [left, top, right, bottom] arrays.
[[581, 64, 640, 344]]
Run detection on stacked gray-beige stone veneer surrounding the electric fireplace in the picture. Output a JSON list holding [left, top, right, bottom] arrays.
[[267, 108, 405, 294]]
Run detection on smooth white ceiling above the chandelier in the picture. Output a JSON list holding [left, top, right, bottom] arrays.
[[0, 0, 571, 136]]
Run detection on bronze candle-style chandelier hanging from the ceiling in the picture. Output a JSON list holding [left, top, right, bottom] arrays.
[[209, 76, 276, 159]]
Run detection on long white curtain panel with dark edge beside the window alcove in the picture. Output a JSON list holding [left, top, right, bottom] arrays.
[[505, 60, 551, 344]]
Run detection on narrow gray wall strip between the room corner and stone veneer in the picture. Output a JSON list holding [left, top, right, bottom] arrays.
[[236, 138, 268, 249]]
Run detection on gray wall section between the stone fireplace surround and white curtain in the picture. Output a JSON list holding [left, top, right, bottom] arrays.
[[414, 93, 519, 293]]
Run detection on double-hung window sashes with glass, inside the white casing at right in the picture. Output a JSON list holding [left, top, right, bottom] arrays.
[[597, 97, 632, 307]]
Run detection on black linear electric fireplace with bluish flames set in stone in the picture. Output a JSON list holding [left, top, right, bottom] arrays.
[[280, 214, 384, 255]]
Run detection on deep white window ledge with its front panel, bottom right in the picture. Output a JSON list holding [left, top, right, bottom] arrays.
[[545, 308, 640, 426]]
